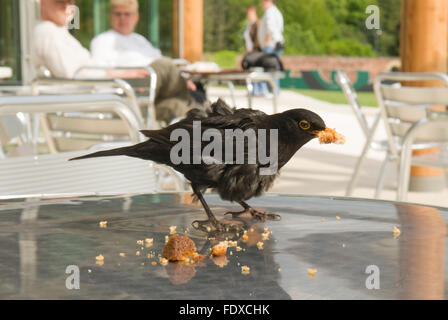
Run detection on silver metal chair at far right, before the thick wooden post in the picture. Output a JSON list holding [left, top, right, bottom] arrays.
[[374, 73, 448, 200]]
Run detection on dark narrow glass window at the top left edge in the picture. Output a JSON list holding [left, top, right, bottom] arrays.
[[0, 0, 21, 84]]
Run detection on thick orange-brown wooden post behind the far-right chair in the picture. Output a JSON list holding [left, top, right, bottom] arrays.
[[401, 0, 448, 191]]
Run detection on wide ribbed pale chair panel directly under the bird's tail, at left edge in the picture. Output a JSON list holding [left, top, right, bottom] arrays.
[[0, 151, 157, 197]]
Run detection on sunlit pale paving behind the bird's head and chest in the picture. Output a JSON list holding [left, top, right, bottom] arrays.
[[208, 87, 448, 207]]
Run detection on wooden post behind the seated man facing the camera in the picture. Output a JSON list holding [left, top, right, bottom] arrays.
[[173, 0, 204, 62]]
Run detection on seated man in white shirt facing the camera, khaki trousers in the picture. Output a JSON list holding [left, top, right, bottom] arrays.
[[90, 0, 201, 122]]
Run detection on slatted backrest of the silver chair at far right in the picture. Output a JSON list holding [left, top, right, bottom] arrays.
[[374, 72, 448, 155]]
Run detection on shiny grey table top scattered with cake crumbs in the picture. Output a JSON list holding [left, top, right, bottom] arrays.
[[0, 194, 448, 300]]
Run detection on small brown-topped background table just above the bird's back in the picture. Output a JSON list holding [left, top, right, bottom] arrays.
[[181, 69, 285, 113]]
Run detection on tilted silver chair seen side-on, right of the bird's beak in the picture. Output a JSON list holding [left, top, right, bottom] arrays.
[[336, 70, 390, 199]]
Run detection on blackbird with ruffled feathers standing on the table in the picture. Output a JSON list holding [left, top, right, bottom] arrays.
[[71, 99, 326, 230]]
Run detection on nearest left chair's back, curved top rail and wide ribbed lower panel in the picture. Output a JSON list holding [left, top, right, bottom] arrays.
[[0, 94, 157, 197]]
